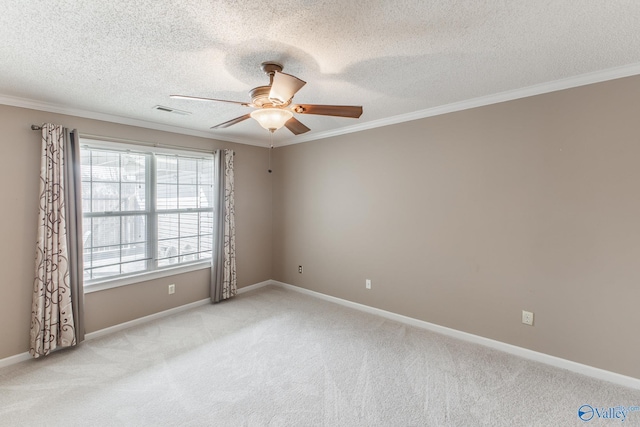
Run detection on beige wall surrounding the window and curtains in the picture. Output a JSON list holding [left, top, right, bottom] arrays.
[[0, 105, 272, 359]]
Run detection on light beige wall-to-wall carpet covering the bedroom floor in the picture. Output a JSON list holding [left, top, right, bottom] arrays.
[[0, 287, 640, 426]]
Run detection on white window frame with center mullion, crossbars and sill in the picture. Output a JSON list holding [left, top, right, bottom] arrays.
[[80, 137, 217, 293]]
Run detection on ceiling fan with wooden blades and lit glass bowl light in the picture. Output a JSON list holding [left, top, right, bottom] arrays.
[[170, 62, 362, 135]]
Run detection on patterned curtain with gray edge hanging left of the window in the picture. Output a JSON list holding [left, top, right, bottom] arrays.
[[29, 124, 84, 357]]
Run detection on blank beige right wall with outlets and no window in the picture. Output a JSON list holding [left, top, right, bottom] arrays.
[[273, 77, 640, 378]]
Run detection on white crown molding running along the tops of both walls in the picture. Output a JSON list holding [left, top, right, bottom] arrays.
[[0, 63, 640, 148]]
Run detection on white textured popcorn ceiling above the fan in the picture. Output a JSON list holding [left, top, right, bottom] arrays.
[[0, 0, 640, 145]]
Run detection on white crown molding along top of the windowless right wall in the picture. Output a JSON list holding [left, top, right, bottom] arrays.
[[278, 63, 640, 147]]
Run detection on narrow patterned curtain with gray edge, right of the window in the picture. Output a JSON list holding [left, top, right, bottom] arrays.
[[211, 150, 237, 302]]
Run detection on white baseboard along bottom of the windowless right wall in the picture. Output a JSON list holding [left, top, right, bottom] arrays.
[[271, 280, 640, 390]]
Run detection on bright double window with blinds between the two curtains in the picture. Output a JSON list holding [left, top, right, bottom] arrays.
[[80, 141, 213, 284]]
